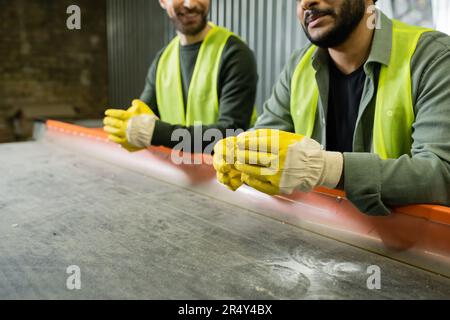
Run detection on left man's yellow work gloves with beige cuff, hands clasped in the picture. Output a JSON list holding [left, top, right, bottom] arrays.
[[103, 100, 158, 152]]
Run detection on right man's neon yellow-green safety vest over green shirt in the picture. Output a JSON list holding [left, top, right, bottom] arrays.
[[291, 20, 433, 159]]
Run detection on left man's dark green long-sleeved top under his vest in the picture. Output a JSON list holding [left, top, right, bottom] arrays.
[[141, 37, 258, 153]]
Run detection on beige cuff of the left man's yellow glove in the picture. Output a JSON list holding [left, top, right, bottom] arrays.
[[126, 114, 158, 148]]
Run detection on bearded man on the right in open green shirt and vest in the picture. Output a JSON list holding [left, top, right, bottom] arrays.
[[214, 0, 450, 215]]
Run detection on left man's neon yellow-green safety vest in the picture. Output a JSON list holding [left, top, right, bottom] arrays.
[[156, 23, 233, 126]]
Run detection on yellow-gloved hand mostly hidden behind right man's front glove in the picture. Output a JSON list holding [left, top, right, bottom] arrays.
[[213, 137, 243, 191]]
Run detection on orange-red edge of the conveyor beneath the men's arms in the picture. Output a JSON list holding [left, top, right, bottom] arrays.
[[47, 121, 450, 277]]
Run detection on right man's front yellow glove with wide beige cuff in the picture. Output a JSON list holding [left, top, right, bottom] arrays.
[[235, 129, 344, 195]]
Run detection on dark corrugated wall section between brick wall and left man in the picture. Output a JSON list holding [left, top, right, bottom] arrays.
[[107, 0, 164, 108]]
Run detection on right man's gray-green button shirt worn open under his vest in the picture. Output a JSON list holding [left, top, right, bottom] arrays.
[[255, 13, 450, 215]]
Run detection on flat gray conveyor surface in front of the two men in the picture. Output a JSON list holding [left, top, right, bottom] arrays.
[[0, 141, 450, 299]]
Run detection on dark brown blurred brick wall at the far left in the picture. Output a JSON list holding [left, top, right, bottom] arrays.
[[0, 0, 107, 141]]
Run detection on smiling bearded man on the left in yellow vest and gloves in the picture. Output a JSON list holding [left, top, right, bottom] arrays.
[[104, 0, 258, 153]]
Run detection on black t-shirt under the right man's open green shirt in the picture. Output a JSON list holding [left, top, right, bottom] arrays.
[[327, 59, 366, 152]]
